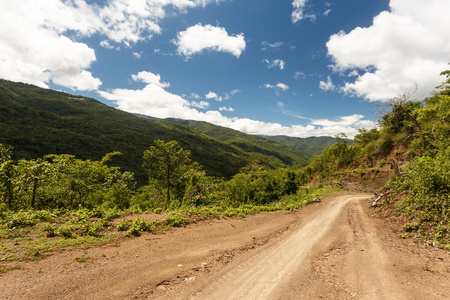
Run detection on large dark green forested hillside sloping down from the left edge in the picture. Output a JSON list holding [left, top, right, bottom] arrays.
[[0, 80, 280, 183]]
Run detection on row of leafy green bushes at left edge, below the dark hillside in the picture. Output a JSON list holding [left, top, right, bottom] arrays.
[[0, 144, 135, 209]]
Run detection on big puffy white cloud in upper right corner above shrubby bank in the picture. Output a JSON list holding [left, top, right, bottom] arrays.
[[327, 0, 450, 101]]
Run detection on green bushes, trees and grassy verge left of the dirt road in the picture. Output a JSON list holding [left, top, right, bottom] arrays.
[[0, 140, 333, 272]]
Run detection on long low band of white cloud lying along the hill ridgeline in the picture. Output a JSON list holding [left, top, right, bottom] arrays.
[[98, 72, 375, 138]]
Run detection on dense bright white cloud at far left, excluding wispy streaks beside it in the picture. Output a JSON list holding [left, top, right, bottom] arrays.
[[0, 0, 101, 90]]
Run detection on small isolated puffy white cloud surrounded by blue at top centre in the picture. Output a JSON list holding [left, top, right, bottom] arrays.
[[172, 24, 246, 58]]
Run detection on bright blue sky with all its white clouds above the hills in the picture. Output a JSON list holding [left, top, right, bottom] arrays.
[[0, 0, 450, 137]]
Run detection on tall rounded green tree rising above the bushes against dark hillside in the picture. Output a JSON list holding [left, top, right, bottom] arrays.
[[144, 140, 198, 205]]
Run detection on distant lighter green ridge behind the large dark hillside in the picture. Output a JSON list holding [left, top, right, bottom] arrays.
[[167, 119, 312, 167]]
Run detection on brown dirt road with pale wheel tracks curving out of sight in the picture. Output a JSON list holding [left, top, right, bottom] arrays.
[[0, 195, 450, 299]]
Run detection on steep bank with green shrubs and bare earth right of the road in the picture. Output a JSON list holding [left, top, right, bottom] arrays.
[[299, 71, 450, 249]]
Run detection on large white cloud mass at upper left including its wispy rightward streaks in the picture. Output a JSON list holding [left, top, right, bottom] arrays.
[[0, 0, 224, 91]]
